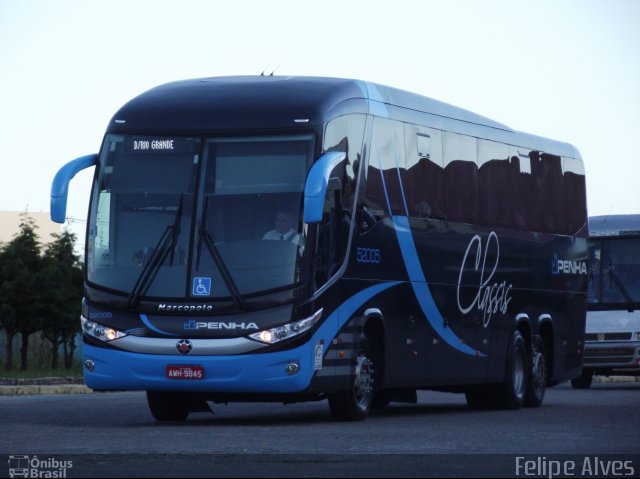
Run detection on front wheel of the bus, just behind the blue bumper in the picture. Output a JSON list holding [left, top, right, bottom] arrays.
[[328, 337, 376, 421]]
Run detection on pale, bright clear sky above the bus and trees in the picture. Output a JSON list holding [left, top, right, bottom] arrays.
[[0, 0, 640, 246]]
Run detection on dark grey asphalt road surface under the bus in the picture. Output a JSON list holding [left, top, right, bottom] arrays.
[[0, 382, 640, 477]]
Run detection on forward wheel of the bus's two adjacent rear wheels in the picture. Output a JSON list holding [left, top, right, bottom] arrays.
[[496, 331, 529, 409]]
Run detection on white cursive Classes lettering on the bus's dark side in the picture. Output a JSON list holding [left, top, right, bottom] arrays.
[[458, 231, 513, 328]]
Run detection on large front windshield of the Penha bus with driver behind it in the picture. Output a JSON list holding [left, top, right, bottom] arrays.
[[87, 135, 313, 306]]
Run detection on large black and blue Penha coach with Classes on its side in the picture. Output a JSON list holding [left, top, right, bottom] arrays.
[[51, 76, 588, 420]]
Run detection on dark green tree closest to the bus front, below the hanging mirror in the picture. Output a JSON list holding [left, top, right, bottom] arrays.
[[37, 231, 83, 369]]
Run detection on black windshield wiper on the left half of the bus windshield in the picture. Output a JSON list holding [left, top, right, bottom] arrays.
[[127, 194, 184, 308]]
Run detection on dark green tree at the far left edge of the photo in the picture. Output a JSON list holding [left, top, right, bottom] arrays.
[[0, 213, 43, 370]]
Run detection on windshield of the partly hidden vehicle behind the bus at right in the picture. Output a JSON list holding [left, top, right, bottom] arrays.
[[588, 236, 640, 308]]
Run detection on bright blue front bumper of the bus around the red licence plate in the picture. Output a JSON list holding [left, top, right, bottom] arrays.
[[83, 343, 314, 394]]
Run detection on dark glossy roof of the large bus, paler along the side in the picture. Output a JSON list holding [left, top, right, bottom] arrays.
[[109, 75, 580, 159]]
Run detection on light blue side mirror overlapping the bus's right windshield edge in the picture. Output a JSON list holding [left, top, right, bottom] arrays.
[[303, 151, 347, 223]]
